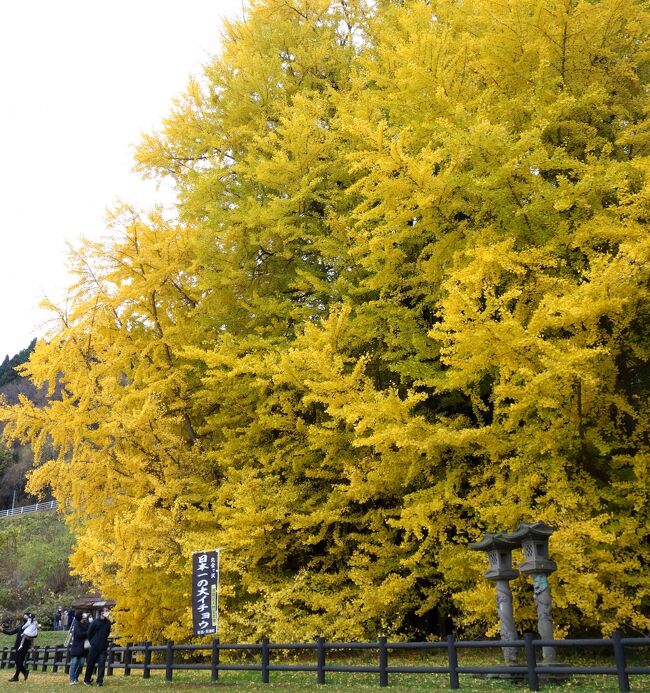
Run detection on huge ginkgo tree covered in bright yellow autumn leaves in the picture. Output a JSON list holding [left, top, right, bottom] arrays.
[[2, 0, 650, 640]]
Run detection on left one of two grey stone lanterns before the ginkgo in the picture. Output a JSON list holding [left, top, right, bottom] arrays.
[[469, 533, 519, 664]]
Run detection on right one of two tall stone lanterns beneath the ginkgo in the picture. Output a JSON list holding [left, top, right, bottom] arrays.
[[505, 522, 557, 664]]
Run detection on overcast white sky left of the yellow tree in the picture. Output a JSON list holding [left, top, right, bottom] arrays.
[[0, 0, 242, 361]]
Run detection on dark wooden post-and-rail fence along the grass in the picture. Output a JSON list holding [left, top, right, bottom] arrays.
[[0, 631, 650, 692]]
